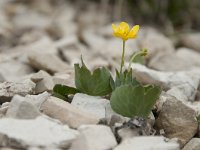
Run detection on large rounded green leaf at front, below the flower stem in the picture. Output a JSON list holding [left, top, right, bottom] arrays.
[[110, 85, 161, 118]]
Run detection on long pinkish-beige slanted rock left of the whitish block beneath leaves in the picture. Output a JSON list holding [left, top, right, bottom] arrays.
[[40, 97, 99, 128]]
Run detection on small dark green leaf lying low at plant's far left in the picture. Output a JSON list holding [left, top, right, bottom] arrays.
[[53, 84, 79, 101]]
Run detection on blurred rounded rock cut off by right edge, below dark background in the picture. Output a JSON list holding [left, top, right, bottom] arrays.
[[180, 32, 200, 51]]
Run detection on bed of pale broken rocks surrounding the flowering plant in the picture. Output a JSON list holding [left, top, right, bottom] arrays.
[[0, 0, 200, 150]]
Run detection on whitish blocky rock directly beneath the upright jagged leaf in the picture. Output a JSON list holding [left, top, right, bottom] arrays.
[[71, 93, 110, 118]]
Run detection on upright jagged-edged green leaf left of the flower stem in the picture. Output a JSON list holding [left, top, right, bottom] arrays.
[[74, 60, 112, 96]]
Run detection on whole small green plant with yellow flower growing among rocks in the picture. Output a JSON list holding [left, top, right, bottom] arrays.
[[53, 22, 161, 118]]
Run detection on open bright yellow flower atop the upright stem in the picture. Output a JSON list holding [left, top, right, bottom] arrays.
[[112, 22, 140, 41]]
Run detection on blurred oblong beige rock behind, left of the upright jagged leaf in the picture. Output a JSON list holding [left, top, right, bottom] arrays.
[[28, 52, 69, 73]]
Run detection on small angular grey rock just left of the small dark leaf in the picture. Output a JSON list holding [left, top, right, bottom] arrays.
[[31, 70, 54, 94]]
